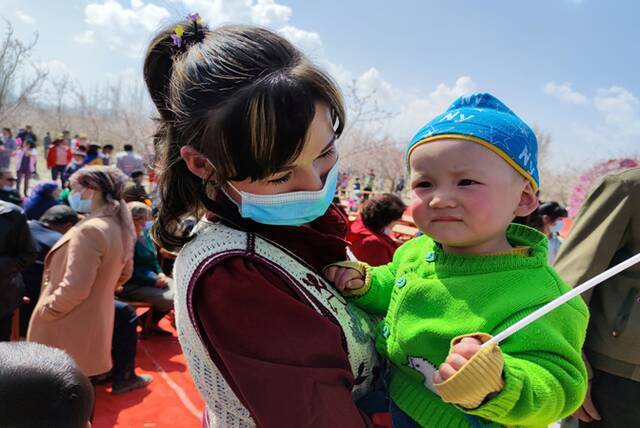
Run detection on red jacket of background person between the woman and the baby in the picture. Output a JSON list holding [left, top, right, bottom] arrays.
[[347, 216, 398, 266]]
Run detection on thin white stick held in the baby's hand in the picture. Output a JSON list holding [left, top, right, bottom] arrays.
[[482, 253, 640, 346]]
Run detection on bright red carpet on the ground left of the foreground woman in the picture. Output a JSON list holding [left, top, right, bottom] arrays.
[[93, 319, 204, 428]]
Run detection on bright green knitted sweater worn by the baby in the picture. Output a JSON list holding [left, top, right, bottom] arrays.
[[353, 225, 589, 428]]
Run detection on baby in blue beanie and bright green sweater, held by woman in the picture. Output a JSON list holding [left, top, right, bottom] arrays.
[[325, 93, 588, 427]]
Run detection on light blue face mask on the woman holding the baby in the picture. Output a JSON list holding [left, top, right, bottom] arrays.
[[228, 161, 338, 226]]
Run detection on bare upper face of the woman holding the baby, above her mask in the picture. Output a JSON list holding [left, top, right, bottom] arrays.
[[227, 103, 338, 198]]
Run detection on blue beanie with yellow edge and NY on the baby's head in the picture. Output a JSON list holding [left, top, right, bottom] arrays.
[[406, 93, 540, 191]]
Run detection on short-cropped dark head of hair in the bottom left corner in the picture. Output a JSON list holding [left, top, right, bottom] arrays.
[[0, 342, 94, 428]]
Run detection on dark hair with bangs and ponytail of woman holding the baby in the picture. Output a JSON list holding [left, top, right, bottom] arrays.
[[144, 20, 345, 250]]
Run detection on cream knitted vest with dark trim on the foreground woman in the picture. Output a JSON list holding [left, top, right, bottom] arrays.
[[174, 220, 381, 428]]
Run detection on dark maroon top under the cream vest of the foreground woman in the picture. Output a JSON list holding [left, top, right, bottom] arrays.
[[193, 199, 372, 428]]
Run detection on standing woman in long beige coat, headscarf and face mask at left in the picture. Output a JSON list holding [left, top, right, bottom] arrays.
[[27, 166, 135, 376]]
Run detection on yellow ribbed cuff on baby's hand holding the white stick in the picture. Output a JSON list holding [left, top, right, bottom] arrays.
[[435, 333, 504, 409]]
